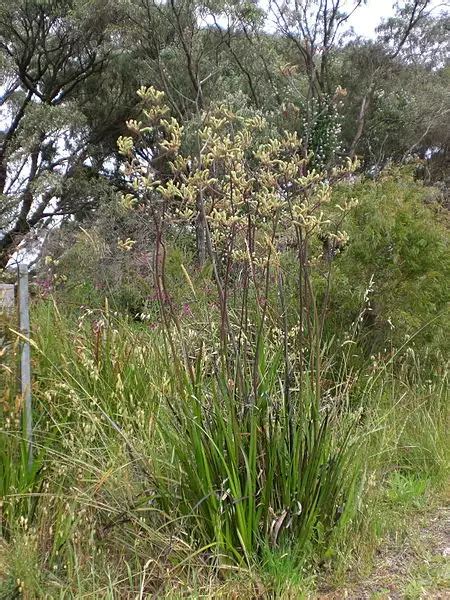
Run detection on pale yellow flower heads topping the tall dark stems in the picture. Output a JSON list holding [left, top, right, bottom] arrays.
[[118, 87, 356, 272]]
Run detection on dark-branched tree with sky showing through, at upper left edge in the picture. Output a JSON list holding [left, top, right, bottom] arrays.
[[0, 0, 138, 266]]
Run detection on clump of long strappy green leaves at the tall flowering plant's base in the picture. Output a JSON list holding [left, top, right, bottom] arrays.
[[158, 343, 358, 565]]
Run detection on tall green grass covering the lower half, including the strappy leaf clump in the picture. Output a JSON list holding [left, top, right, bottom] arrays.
[[0, 303, 448, 599]]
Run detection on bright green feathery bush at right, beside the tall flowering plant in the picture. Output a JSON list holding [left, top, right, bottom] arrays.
[[320, 169, 450, 358]]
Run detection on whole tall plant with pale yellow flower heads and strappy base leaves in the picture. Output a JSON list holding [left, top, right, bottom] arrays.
[[118, 87, 362, 562]]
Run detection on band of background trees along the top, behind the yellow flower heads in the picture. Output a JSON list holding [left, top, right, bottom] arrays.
[[0, 0, 449, 266]]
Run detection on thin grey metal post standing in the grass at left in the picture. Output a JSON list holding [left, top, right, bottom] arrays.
[[19, 265, 33, 467]]
